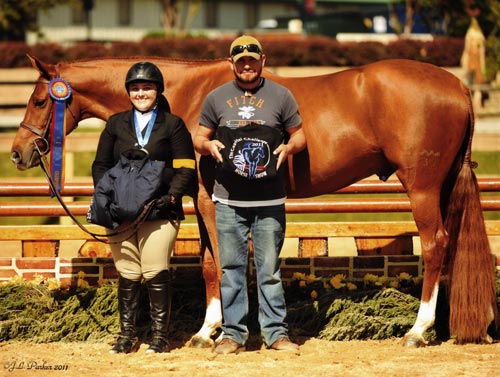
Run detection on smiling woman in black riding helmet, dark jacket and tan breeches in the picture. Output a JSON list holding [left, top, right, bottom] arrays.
[[92, 62, 196, 353]]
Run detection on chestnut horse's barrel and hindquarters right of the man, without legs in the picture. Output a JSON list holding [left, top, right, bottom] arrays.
[[278, 60, 470, 196]]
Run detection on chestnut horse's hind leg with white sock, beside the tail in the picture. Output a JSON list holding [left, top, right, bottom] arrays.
[[404, 189, 448, 347]]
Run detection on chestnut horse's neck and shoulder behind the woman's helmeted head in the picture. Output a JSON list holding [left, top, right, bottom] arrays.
[[63, 58, 232, 125]]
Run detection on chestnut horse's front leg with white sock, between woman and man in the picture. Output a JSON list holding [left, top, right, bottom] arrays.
[[189, 188, 222, 348]]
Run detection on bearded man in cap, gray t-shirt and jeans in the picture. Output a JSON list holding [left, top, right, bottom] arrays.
[[194, 35, 306, 354]]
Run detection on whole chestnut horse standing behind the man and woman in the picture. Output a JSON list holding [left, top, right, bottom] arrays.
[[11, 57, 498, 346]]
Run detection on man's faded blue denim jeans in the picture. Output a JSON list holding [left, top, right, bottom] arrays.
[[216, 203, 288, 346]]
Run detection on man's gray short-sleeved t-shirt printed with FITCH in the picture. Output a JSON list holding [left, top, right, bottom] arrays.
[[200, 79, 302, 207]]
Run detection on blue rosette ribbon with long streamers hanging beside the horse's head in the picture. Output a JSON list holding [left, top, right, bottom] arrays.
[[49, 77, 71, 197]]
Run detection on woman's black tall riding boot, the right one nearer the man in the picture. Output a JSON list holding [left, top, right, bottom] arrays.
[[146, 270, 172, 353]]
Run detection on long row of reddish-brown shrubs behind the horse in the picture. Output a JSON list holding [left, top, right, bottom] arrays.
[[0, 35, 464, 68]]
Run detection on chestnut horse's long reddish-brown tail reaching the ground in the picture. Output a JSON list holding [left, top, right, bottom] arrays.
[[445, 89, 499, 343]]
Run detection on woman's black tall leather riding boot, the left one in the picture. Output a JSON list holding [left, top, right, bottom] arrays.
[[109, 276, 141, 353]]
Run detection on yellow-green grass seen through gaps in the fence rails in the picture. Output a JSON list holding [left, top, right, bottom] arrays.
[[0, 151, 500, 225]]
